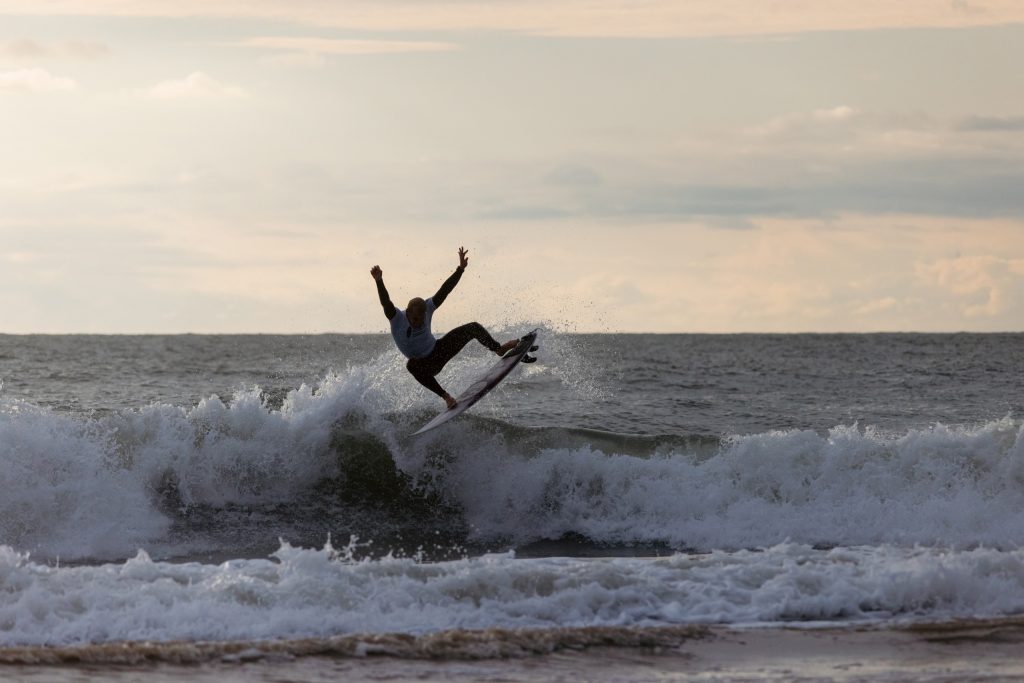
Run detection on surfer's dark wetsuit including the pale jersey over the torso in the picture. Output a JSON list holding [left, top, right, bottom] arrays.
[[377, 266, 501, 398]]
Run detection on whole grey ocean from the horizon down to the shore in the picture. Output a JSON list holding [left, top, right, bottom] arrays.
[[0, 325, 1024, 680]]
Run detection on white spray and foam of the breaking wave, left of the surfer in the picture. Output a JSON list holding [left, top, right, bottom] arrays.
[[0, 358, 407, 559]]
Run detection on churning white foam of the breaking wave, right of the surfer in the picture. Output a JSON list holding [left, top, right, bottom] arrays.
[[425, 419, 1024, 549]]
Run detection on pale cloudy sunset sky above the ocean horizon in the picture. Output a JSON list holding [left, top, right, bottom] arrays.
[[0, 0, 1024, 334]]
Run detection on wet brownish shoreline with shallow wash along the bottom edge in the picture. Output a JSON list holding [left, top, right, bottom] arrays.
[[6, 616, 1024, 681]]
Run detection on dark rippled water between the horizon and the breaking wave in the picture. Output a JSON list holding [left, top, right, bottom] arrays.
[[6, 333, 1024, 436]]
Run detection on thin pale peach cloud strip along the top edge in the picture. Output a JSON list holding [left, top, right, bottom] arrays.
[[0, 0, 1024, 37]]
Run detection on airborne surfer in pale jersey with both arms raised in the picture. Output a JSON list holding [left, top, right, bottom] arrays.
[[370, 247, 519, 409]]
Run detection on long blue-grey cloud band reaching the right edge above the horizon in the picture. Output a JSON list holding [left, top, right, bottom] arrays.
[[468, 157, 1024, 229]]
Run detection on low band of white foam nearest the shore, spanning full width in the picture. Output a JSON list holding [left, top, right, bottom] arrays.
[[0, 544, 1024, 646]]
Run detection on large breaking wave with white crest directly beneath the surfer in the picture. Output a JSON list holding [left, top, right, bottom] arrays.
[[0, 348, 1024, 560]]
